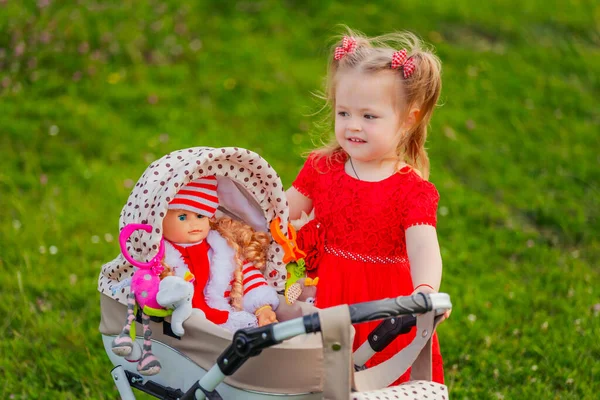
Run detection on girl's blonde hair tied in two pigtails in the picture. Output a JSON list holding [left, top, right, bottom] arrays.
[[315, 27, 442, 179]]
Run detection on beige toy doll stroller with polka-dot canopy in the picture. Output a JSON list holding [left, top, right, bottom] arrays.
[[98, 147, 451, 399]]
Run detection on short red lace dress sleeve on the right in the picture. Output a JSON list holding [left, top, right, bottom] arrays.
[[403, 181, 440, 230]]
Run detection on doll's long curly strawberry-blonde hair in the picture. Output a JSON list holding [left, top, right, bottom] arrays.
[[210, 217, 270, 311]]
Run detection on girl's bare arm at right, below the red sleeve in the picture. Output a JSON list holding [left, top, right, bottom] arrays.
[[406, 225, 442, 293]]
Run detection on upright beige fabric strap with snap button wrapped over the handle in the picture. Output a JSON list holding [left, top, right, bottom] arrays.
[[319, 305, 354, 400]]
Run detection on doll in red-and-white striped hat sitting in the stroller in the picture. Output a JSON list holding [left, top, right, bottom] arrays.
[[163, 176, 279, 331]]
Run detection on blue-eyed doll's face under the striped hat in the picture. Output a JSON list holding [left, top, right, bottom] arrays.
[[163, 210, 210, 243]]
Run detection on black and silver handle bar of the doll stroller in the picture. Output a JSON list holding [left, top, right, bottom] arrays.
[[181, 293, 452, 400]]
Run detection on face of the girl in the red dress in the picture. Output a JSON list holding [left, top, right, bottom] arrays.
[[335, 71, 403, 162]]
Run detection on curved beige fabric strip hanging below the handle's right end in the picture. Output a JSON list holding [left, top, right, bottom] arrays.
[[354, 311, 435, 391]]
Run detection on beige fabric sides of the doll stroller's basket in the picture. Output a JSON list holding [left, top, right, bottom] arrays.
[[100, 295, 323, 394]]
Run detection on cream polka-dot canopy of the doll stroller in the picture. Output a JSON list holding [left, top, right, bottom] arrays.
[[98, 147, 288, 304]]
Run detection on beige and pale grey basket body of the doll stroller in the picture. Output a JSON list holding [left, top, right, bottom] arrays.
[[100, 295, 323, 394]]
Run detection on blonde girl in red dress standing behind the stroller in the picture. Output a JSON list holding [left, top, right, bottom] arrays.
[[287, 31, 444, 383]]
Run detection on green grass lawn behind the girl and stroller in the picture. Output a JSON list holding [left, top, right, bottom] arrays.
[[0, 0, 600, 399]]
